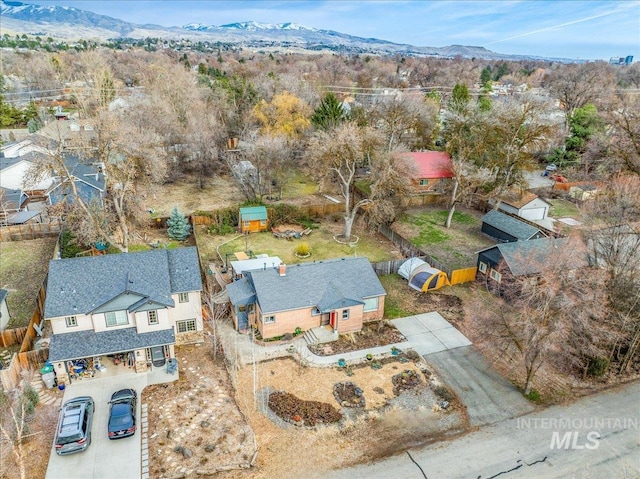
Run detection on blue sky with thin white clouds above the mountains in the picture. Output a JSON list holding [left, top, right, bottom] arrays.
[[27, 0, 640, 61]]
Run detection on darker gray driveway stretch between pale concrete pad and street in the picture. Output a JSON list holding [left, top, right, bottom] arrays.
[[425, 346, 535, 426]]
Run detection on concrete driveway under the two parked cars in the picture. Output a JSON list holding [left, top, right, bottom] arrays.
[[46, 373, 147, 479]]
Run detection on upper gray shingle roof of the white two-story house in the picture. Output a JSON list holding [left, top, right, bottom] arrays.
[[44, 247, 202, 318]]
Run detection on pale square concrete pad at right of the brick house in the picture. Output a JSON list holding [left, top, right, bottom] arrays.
[[391, 312, 471, 356]]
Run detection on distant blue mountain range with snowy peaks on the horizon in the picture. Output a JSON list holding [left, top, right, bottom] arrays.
[[0, 0, 561, 60]]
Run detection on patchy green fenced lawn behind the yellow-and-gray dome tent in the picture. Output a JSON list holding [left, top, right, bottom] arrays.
[[393, 207, 495, 269]]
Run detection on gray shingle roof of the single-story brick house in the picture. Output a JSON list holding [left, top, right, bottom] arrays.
[[247, 258, 386, 314]]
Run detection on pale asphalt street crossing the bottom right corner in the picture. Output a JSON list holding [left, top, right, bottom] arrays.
[[323, 382, 640, 479]]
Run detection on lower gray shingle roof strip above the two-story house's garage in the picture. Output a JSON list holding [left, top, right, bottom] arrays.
[[49, 328, 176, 361]]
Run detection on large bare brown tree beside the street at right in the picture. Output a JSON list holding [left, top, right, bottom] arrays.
[[478, 238, 610, 394]]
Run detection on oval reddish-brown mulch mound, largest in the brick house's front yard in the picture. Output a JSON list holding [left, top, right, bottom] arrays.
[[269, 391, 342, 426]]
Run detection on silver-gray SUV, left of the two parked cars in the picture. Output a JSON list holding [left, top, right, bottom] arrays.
[[55, 396, 95, 456]]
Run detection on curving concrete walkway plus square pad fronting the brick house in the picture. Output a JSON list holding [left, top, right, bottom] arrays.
[[218, 313, 471, 367]]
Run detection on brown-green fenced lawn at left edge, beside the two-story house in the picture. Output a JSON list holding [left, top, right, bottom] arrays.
[[0, 238, 56, 328]]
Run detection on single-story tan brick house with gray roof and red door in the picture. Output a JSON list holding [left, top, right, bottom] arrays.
[[227, 258, 386, 339]]
